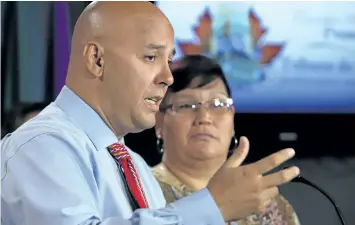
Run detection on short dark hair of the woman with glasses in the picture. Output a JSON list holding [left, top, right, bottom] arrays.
[[160, 55, 231, 111]]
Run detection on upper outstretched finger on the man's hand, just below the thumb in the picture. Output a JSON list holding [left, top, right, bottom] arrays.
[[252, 148, 295, 174]]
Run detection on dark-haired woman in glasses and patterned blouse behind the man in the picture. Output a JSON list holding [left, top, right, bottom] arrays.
[[153, 55, 299, 225]]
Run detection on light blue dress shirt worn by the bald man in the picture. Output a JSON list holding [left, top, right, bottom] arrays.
[[1, 86, 224, 225]]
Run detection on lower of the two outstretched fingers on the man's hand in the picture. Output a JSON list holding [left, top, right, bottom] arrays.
[[262, 166, 300, 188]]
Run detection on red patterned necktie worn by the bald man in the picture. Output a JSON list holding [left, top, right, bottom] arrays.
[[108, 143, 149, 208]]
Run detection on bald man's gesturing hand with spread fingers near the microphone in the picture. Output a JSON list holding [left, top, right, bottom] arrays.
[[207, 137, 299, 221]]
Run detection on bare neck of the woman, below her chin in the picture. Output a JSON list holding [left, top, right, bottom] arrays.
[[163, 155, 225, 191]]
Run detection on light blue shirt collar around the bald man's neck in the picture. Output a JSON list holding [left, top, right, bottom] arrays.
[[55, 86, 124, 150]]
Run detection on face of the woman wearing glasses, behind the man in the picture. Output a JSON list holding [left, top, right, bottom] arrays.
[[156, 78, 234, 160]]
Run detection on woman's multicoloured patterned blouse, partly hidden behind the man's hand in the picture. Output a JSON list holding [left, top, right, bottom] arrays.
[[152, 163, 300, 225]]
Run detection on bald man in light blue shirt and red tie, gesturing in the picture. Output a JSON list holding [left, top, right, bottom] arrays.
[[1, 2, 298, 225]]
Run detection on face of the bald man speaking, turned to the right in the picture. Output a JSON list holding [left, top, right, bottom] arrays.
[[96, 13, 174, 132]]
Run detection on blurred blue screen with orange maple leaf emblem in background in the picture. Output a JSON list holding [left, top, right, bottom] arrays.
[[157, 2, 355, 113]]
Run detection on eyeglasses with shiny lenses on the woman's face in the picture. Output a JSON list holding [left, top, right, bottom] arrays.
[[160, 98, 233, 114]]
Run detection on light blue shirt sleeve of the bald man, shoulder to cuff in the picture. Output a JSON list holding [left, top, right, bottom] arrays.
[[1, 134, 224, 225]]
